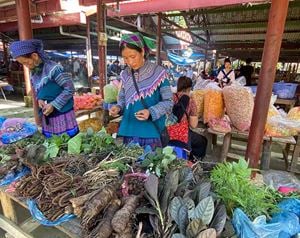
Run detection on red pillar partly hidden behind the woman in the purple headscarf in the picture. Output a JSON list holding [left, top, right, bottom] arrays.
[[16, 0, 40, 124]]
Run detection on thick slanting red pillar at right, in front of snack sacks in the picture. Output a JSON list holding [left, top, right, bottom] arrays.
[[246, 0, 289, 171]]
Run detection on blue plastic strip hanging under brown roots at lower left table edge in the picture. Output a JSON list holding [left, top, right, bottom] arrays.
[[27, 199, 76, 226]]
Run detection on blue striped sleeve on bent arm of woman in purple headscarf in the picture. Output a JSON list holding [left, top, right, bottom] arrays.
[[51, 67, 75, 111]]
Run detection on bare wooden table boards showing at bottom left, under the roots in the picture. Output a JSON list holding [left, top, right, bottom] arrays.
[[0, 187, 82, 238]]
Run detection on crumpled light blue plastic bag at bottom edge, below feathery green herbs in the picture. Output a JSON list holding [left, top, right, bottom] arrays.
[[232, 208, 282, 238]]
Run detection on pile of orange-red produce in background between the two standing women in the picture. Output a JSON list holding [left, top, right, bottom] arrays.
[[73, 94, 103, 111]]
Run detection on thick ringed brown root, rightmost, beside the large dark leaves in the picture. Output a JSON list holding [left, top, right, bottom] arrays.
[[111, 195, 140, 234]]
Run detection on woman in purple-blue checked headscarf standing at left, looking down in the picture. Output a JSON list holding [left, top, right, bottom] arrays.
[[10, 39, 79, 137]]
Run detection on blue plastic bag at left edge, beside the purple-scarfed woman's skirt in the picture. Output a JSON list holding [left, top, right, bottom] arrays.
[[0, 122, 38, 144]]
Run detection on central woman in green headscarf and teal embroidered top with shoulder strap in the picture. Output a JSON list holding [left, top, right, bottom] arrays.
[[110, 33, 173, 148]]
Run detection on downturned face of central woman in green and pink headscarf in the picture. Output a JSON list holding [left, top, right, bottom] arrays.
[[122, 47, 145, 70]]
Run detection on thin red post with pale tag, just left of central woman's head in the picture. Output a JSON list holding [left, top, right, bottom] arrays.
[[97, 0, 107, 97]]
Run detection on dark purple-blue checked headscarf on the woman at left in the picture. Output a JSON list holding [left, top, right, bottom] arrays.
[[9, 39, 48, 61]]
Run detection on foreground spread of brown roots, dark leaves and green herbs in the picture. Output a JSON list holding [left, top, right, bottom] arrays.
[[0, 123, 299, 238]]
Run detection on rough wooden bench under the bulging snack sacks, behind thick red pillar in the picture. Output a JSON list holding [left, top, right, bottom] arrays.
[[207, 128, 299, 170]]
